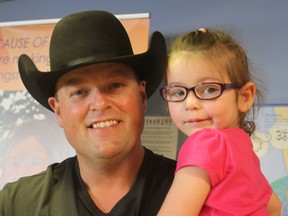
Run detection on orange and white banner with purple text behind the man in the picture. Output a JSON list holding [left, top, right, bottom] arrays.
[[0, 13, 150, 188]]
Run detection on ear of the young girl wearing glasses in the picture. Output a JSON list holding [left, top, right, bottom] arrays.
[[238, 82, 256, 113]]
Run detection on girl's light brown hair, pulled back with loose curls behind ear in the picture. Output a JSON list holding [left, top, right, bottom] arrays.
[[168, 28, 264, 135]]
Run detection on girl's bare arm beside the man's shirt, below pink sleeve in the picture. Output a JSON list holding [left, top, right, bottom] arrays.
[[158, 166, 211, 216]]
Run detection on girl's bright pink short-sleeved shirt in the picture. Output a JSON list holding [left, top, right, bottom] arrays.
[[176, 128, 272, 216]]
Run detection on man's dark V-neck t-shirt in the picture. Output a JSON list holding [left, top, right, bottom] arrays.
[[0, 149, 176, 216]]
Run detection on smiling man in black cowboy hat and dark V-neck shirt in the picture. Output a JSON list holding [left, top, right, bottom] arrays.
[[0, 11, 175, 216]]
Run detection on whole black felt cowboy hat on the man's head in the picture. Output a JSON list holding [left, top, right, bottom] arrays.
[[18, 11, 166, 111]]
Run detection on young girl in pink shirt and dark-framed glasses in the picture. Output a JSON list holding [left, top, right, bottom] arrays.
[[158, 29, 281, 216]]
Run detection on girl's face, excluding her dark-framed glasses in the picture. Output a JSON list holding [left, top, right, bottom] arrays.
[[167, 53, 252, 136]]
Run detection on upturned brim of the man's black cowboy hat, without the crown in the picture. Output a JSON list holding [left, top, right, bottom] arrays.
[[18, 32, 167, 112]]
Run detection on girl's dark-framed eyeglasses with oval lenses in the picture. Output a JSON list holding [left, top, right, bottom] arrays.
[[160, 82, 241, 102]]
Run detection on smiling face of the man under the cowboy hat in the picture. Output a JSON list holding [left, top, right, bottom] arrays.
[[49, 63, 147, 164]]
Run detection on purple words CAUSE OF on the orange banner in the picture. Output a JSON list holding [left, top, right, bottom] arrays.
[[0, 36, 49, 49]]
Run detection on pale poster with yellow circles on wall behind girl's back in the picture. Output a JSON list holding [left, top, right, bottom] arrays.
[[252, 106, 288, 212]]
